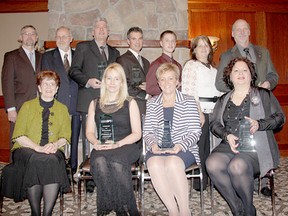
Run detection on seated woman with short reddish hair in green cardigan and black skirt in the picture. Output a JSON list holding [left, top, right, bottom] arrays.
[[12, 71, 71, 216]]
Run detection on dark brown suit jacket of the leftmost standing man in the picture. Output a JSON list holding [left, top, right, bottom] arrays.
[[1, 47, 42, 111]]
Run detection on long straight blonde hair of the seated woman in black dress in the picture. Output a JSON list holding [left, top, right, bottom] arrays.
[[99, 63, 129, 108]]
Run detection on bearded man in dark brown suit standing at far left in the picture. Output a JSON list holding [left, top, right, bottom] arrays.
[[1, 25, 42, 157]]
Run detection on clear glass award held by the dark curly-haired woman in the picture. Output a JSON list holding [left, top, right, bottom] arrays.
[[237, 119, 256, 152]]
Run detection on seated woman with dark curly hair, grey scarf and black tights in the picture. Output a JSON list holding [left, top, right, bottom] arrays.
[[206, 58, 285, 216]]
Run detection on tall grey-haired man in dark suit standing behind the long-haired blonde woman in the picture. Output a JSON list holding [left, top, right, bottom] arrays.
[[69, 17, 120, 160]]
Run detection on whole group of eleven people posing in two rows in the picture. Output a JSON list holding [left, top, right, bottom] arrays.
[[2, 17, 285, 216]]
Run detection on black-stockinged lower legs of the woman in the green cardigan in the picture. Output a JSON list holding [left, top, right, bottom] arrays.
[[27, 183, 59, 216]]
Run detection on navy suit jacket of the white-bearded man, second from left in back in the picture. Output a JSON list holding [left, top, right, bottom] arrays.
[[41, 48, 78, 115]]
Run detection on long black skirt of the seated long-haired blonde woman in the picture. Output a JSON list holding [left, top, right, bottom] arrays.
[[91, 156, 139, 216]]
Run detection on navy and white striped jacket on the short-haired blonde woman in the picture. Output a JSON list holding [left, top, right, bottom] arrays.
[[143, 90, 201, 163]]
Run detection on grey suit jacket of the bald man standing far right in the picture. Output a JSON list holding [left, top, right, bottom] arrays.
[[215, 44, 279, 92]]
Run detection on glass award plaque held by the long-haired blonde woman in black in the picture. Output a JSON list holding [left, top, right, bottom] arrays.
[[98, 114, 114, 144]]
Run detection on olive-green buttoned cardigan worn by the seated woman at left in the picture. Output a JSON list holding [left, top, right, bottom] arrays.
[[11, 98, 71, 151]]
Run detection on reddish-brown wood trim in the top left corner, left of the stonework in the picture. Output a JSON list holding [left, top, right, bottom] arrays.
[[0, 0, 48, 13]]
